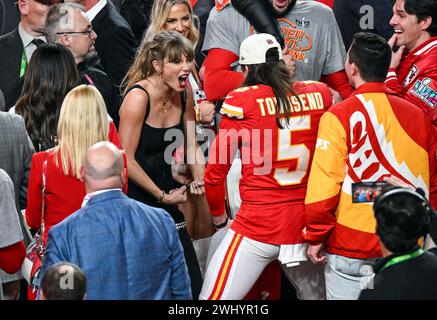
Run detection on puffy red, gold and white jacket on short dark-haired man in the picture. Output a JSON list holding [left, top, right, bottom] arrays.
[[303, 83, 437, 259]]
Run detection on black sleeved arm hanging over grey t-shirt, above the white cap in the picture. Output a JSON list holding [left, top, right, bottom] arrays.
[[232, 0, 284, 48]]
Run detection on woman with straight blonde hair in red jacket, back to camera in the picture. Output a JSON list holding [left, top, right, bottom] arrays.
[[26, 85, 120, 243]]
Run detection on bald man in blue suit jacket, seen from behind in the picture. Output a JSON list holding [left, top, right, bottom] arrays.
[[42, 141, 192, 300]]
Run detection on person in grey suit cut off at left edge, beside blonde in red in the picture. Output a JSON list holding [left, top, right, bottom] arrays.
[[0, 112, 35, 296]]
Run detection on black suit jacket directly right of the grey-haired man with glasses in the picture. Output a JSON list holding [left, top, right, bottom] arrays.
[[91, 1, 136, 86]]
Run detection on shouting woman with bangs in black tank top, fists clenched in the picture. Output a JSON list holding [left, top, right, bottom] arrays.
[[120, 31, 204, 299]]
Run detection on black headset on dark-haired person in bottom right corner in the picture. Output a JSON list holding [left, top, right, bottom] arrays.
[[373, 188, 433, 235]]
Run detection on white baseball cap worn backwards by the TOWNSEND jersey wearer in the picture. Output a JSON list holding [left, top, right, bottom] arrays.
[[239, 33, 282, 65]]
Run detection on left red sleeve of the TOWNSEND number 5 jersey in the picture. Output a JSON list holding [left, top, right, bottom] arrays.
[[205, 116, 240, 216]]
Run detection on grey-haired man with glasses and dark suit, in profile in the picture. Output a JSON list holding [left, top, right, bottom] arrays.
[[45, 3, 121, 127]]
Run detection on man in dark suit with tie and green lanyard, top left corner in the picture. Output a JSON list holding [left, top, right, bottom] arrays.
[[0, 0, 59, 102]]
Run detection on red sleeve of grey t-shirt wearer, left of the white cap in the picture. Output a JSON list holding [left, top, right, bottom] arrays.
[[204, 49, 244, 101]]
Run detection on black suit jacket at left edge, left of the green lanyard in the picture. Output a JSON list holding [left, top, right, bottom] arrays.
[[0, 28, 23, 97]]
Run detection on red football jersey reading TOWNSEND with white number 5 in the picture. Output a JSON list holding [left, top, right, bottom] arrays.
[[205, 81, 332, 243]]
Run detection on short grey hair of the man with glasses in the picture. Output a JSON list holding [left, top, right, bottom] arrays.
[[45, 2, 85, 43]]
